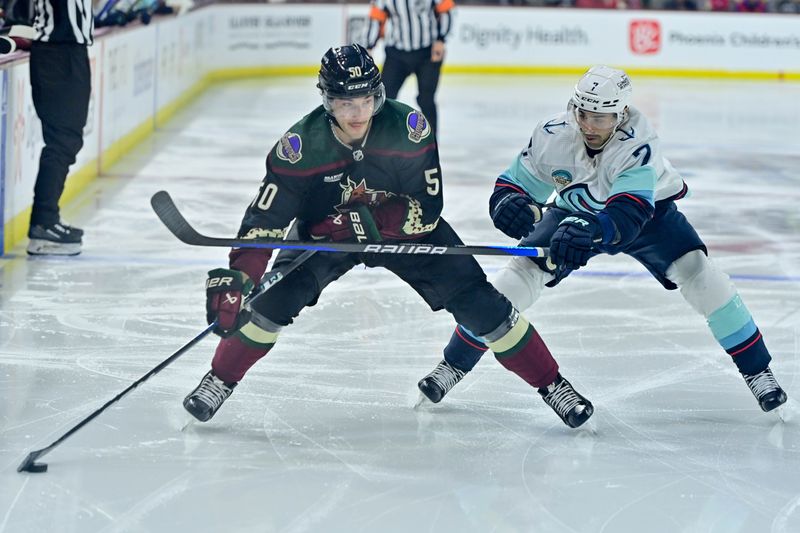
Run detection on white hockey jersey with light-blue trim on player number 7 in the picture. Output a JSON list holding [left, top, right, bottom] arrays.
[[499, 107, 685, 213]]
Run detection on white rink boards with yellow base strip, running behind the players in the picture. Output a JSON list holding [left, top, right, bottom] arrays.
[[0, 4, 800, 252]]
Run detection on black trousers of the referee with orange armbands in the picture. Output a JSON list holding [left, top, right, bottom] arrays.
[[381, 46, 442, 133]]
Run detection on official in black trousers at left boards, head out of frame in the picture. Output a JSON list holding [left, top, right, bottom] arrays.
[[28, 0, 94, 255]]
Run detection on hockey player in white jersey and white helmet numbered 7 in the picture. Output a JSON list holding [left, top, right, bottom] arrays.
[[419, 66, 786, 418]]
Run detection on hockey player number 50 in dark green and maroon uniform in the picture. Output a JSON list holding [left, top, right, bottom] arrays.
[[184, 45, 593, 427]]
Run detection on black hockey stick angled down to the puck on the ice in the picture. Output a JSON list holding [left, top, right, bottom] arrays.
[[17, 250, 314, 473]]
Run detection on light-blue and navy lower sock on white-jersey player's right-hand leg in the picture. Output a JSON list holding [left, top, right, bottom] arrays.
[[708, 293, 772, 374]]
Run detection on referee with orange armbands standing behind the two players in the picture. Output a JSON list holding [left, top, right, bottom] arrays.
[[366, 0, 455, 131]]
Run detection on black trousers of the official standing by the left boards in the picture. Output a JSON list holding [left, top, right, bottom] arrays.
[[30, 42, 92, 226]]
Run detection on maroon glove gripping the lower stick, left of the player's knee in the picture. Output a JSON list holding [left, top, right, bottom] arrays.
[[206, 268, 254, 337]]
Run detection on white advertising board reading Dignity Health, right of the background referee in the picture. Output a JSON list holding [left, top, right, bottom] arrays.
[[447, 7, 800, 72]]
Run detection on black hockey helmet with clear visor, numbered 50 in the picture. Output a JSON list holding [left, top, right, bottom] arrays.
[[317, 44, 386, 115]]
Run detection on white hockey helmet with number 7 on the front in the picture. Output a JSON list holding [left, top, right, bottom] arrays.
[[572, 65, 633, 115]]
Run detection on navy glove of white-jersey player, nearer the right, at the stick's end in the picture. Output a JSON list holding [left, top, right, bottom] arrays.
[[550, 213, 603, 270]]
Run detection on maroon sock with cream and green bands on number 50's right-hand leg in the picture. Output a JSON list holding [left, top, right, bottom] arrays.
[[487, 311, 558, 389]]
